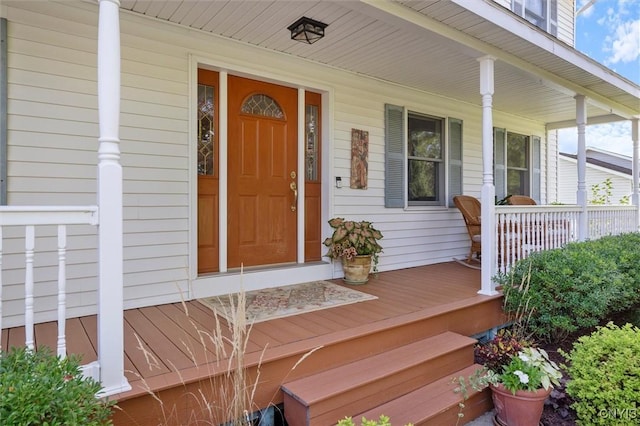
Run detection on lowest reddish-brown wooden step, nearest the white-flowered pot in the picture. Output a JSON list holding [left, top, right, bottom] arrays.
[[353, 364, 493, 426]]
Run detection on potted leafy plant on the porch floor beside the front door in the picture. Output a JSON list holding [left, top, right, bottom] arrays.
[[324, 217, 382, 284]]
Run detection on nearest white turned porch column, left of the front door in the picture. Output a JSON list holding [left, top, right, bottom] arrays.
[[98, 0, 131, 395]]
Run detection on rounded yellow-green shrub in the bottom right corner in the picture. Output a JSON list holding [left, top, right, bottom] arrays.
[[563, 323, 640, 426]]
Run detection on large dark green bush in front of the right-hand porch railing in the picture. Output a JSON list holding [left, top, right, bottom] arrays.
[[495, 233, 640, 341]]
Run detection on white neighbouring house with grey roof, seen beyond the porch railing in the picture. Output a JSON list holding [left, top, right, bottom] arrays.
[[557, 148, 633, 204]]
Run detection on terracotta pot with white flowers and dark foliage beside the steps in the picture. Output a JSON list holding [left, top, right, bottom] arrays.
[[469, 331, 562, 426]]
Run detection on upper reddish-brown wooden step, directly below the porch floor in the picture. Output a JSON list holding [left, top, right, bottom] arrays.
[[282, 331, 476, 426]]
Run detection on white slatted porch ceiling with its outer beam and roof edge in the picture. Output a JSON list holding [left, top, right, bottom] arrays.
[[121, 0, 640, 125]]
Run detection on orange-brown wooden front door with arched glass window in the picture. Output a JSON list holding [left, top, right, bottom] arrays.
[[227, 76, 298, 268]]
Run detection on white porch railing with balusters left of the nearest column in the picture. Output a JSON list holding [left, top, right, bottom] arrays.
[[0, 206, 99, 378]]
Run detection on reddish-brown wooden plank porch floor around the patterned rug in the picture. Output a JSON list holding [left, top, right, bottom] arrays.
[[2, 262, 502, 424]]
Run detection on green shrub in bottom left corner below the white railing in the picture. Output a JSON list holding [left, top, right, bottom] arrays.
[[0, 348, 113, 426]]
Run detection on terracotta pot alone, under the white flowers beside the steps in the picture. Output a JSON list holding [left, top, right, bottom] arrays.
[[491, 384, 551, 426]]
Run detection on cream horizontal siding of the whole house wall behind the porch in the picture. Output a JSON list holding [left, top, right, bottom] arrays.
[[3, 2, 547, 325]]
